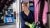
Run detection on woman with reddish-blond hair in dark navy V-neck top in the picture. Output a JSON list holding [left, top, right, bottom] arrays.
[[21, 2, 34, 28]]
